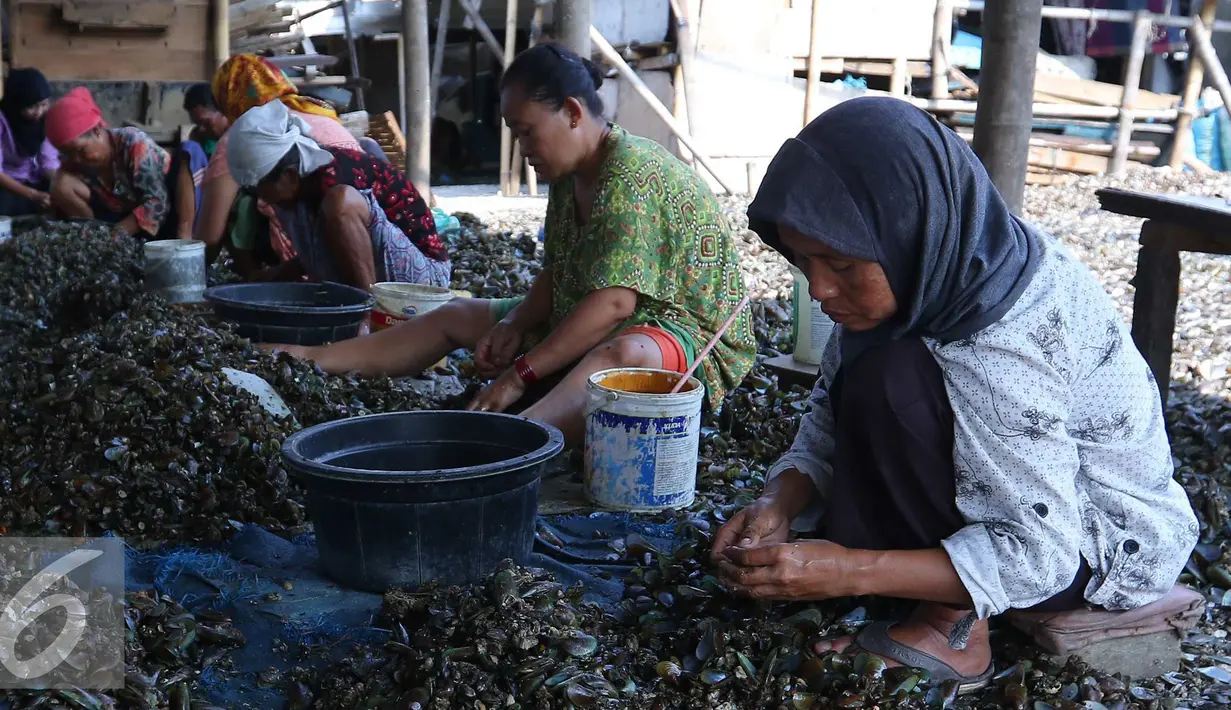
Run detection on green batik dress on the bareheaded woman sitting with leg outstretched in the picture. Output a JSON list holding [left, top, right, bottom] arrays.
[[544, 126, 757, 407]]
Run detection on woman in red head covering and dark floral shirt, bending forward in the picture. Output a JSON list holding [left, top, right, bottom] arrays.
[[47, 86, 204, 239]]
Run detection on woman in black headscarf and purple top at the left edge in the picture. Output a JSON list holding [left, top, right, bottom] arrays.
[[0, 69, 60, 217]]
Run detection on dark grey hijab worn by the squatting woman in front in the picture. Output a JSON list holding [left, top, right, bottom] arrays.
[[748, 98, 1043, 364]]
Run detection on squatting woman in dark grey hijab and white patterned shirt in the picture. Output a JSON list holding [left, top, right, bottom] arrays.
[[713, 98, 1199, 692]]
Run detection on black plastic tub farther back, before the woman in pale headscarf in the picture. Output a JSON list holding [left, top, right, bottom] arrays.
[[204, 282, 375, 345]]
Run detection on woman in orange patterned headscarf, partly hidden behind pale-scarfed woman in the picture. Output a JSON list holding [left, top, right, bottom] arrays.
[[196, 54, 359, 281]]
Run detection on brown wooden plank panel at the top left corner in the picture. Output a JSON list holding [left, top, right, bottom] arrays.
[[10, 0, 214, 81]]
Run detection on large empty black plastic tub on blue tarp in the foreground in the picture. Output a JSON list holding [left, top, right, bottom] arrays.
[[282, 411, 564, 592]]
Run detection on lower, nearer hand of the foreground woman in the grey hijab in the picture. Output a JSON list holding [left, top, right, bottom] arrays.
[[719, 540, 856, 600]]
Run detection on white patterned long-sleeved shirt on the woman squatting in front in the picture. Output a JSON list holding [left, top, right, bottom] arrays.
[[767, 239, 1198, 619]]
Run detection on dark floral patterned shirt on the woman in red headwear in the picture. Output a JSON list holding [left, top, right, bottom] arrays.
[[84, 128, 171, 236]]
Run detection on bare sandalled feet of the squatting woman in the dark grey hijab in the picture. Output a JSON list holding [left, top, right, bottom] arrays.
[[815, 603, 992, 677]]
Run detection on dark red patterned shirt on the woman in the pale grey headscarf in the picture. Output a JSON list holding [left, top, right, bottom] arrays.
[[307, 145, 449, 261]]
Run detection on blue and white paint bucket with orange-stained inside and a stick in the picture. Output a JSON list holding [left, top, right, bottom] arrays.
[[585, 368, 705, 512]]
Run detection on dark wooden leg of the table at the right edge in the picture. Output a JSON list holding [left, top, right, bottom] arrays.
[[1131, 220, 1179, 410]]
